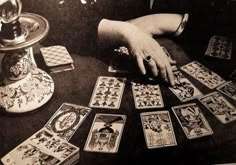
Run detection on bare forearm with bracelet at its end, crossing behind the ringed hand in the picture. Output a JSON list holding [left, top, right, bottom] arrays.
[[127, 14, 183, 35]]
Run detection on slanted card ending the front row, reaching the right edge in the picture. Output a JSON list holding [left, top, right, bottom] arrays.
[[199, 92, 236, 124]]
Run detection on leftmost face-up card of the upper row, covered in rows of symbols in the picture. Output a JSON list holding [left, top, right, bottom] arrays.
[[89, 76, 126, 109]]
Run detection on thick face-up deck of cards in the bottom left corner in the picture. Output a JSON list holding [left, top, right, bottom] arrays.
[[1, 128, 80, 165]]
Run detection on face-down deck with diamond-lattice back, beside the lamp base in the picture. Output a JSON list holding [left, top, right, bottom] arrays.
[[40, 45, 74, 73]]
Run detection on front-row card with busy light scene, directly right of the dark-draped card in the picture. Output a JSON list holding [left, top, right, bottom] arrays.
[[140, 111, 177, 149]]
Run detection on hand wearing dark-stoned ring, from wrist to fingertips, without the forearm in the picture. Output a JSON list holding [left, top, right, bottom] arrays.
[[126, 25, 175, 85]]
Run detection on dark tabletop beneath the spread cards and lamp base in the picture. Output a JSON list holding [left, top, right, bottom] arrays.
[[0, 1, 236, 165]]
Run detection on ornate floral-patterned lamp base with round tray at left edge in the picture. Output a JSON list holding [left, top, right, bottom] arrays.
[[0, 0, 54, 113]]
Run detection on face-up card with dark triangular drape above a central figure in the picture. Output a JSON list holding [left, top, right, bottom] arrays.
[[84, 113, 126, 153]]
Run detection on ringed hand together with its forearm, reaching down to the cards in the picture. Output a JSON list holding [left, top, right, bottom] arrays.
[[98, 19, 175, 86]]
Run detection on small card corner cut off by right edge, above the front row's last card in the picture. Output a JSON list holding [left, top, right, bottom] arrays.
[[216, 81, 236, 100]]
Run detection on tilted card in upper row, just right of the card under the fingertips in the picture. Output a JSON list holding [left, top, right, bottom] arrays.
[[181, 61, 225, 89]]
